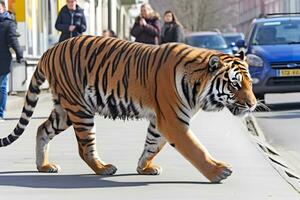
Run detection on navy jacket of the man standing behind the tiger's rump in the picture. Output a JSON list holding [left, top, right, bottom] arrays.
[[55, 5, 86, 42]]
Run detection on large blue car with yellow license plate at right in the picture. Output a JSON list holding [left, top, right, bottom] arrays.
[[237, 14, 300, 100]]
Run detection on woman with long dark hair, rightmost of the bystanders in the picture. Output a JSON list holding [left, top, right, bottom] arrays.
[[161, 10, 184, 44]]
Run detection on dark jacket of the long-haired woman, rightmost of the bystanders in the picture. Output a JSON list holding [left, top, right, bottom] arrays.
[[161, 23, 184, 44]]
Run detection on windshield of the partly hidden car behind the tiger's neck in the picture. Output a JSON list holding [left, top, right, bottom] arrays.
[[187, 35, 228, 50]]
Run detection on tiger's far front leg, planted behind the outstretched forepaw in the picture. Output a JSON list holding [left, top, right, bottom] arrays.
[[137, 121, 166, 175]]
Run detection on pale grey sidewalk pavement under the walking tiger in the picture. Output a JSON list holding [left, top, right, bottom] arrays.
[[0, 93, 300, 200]]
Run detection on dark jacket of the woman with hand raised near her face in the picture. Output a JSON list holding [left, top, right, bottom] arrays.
[[130, 16, 161, 44]]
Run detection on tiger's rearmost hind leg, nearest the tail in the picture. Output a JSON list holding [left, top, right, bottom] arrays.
[[36, 104, 71, 173]]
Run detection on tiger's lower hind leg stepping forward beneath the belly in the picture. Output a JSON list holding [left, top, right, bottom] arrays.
[[70, 115, 117, 175]]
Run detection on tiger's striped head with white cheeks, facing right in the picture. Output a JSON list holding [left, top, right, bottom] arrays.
[[201, 51, 257, 116]]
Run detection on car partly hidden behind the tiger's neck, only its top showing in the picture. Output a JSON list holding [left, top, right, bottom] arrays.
[[186, 32, 232, 54]]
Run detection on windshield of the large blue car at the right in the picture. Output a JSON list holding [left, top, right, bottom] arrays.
[[251, 20, 300, 45]]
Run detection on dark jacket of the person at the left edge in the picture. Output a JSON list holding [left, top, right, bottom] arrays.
[[0, 12, 23, 75]]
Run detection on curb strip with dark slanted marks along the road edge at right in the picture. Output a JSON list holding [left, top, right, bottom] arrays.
[[243, 115, 300, 193]]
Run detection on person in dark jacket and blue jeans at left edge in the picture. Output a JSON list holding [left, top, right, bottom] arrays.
[[0, 1, 23, 121]]
